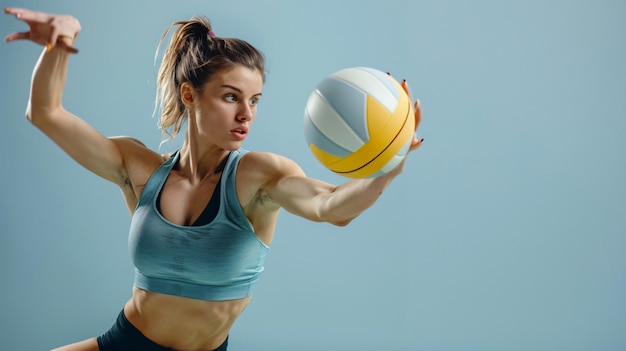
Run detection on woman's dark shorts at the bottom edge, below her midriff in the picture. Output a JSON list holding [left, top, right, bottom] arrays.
[[98, 310, 228, 351]]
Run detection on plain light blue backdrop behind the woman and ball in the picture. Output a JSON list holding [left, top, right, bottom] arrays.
[[0, 0, 626, 351]]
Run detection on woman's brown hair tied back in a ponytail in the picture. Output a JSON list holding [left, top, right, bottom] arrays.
[[155, 16, 265, 140]]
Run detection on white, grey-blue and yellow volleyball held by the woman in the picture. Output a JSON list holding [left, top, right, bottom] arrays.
[[304, 67, 415, 178]]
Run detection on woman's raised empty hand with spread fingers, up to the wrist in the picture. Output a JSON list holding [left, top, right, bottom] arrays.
[[4, 8, 81, 54]]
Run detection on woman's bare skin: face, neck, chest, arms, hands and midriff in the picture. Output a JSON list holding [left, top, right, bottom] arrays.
[[5, 9, 423, 351]]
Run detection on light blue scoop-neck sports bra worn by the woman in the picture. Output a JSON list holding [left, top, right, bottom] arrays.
[[128, 149, 269, 301]]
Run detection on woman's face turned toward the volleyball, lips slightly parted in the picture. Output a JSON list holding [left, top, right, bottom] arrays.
[[194, 65, 263, 150]]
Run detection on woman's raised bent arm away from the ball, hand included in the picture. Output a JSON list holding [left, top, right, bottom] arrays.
[[5, 8, 128, 186]]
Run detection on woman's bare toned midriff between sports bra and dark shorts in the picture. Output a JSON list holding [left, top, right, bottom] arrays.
[[124, 287, 252, 351]]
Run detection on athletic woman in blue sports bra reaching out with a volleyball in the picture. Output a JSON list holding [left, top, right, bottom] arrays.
[[5, 9, 422, 351]]
